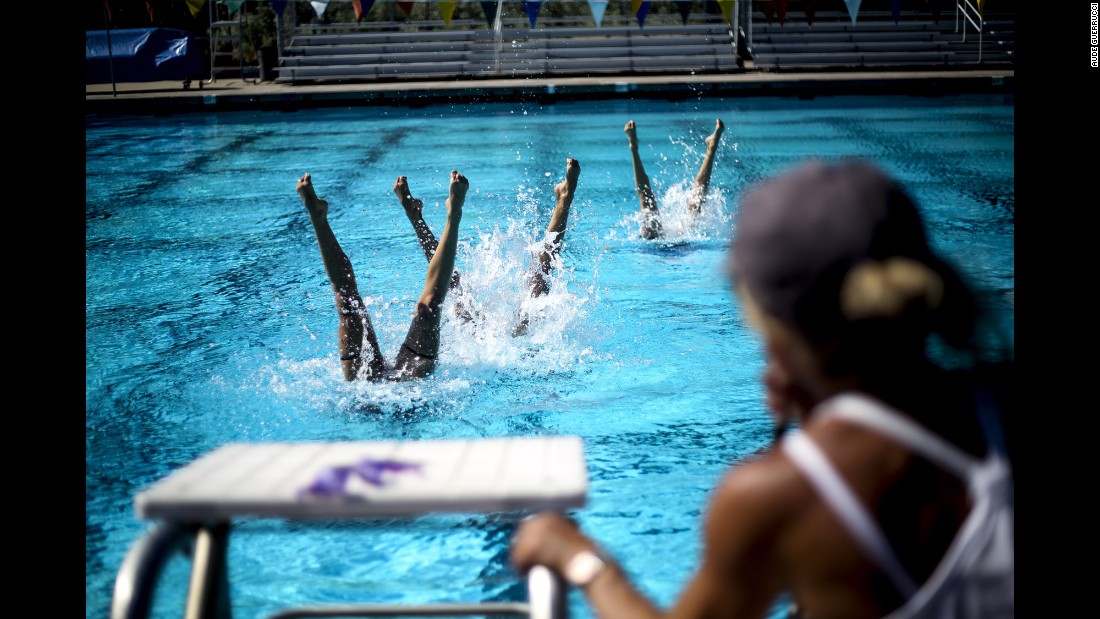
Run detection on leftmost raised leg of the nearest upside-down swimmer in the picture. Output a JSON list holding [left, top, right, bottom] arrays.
[[295, 173, 385, 380]]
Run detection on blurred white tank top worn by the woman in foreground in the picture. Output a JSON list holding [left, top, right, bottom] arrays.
[[782, 393, 1014, 619]]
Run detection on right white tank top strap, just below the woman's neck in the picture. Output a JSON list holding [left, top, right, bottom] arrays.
[[815, 391, 981, 480]]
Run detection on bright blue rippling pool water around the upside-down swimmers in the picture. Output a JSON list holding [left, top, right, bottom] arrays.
[[85, 91, 1015, 619]]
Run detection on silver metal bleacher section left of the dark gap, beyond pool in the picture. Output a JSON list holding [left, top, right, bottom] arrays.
[[276, 16, 739, 84]]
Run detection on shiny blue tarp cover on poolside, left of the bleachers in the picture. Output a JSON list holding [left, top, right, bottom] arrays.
[[84, 27, 202, 84]]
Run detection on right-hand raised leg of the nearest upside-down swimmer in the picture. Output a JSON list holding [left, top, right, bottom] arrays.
[[395, 169, 470, 377]]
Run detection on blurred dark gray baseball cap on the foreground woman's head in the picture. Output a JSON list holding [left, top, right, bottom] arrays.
[[727, 159, 943, 338]]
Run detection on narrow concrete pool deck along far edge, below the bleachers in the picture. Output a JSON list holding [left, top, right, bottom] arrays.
[[85, 67, 1015, 113]]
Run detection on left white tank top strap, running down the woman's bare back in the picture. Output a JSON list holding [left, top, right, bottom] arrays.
[[781, 432, 917, 599]]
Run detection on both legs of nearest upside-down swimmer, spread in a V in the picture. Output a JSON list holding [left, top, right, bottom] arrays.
[[296, 170, 470, 380]]
